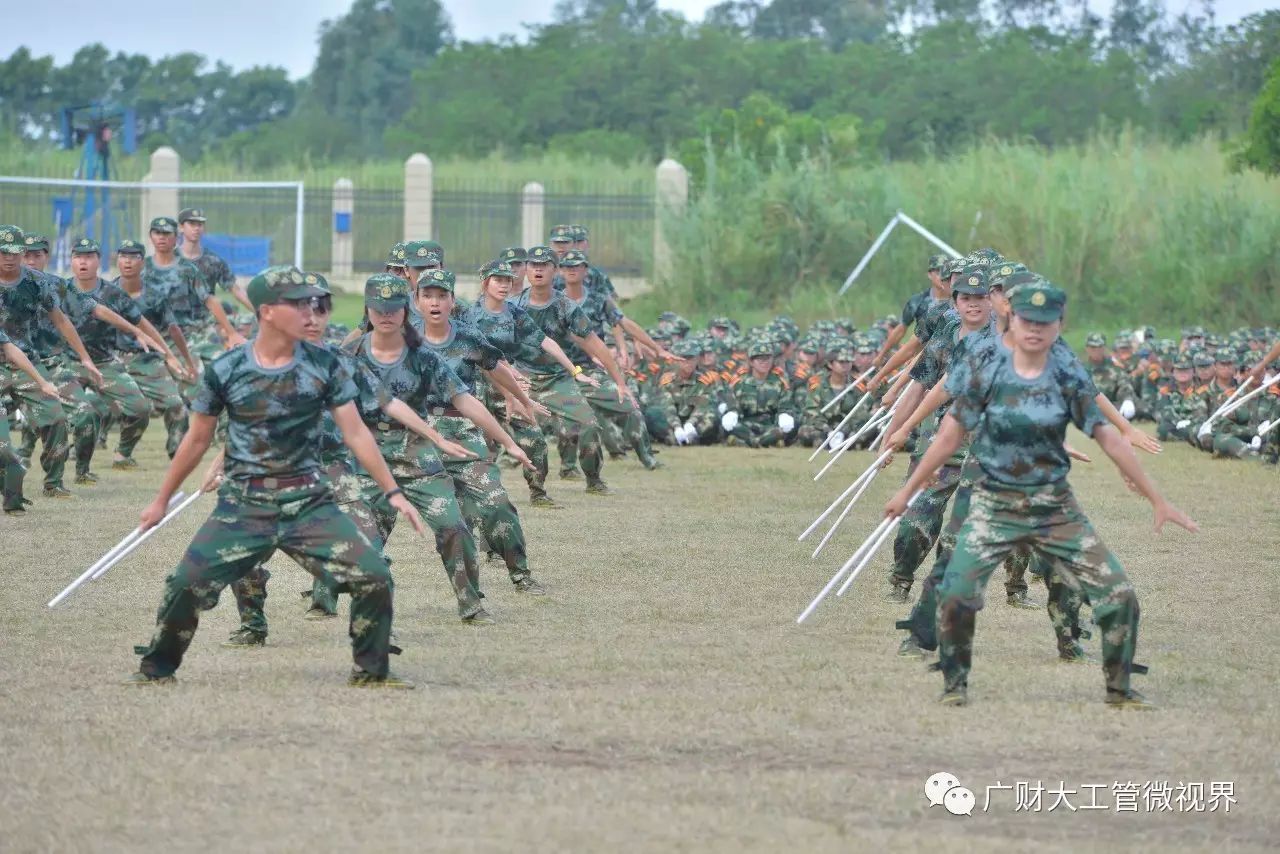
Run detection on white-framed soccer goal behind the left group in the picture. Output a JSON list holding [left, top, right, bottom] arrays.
[[0, 175, 306, 275]]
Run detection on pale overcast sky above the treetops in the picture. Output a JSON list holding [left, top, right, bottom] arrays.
[[15, 0, 1275, 78]]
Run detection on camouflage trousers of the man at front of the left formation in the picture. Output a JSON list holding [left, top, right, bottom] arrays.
[[138, 479, 393, 676]]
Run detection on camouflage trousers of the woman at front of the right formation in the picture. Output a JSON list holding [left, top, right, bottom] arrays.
[[938, 480, 1139, 693]]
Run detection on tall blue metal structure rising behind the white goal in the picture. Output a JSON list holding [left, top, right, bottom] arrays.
[[54, 101, 138, 247]]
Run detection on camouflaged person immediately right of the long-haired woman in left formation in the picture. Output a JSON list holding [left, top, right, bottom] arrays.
[[417, 270, 547, 595]]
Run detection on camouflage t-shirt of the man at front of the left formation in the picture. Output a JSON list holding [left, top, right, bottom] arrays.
[[191, 338, 357, 479]]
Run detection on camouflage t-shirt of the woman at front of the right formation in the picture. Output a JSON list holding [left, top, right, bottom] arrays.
[[951, 350, 1106, 487]]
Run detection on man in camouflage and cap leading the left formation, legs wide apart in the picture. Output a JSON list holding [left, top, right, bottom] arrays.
[[128, 268, 424, 688]]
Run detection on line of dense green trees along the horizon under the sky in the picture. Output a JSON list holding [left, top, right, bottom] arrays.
[[0, 0, 1280, 172]]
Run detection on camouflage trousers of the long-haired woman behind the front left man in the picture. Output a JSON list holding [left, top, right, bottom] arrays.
[[360, 458, 481, 617]]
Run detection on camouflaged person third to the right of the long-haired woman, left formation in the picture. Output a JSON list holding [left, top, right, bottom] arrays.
[[516, 246, 628, 495]]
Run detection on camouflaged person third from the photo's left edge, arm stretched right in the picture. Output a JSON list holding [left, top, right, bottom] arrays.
[[64, 238, 166, 484]]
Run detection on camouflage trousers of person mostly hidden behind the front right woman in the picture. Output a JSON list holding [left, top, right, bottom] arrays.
[[897, 457, 1089, 652]]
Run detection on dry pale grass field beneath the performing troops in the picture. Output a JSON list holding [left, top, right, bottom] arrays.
[[0, 429, 1280, 851]]
